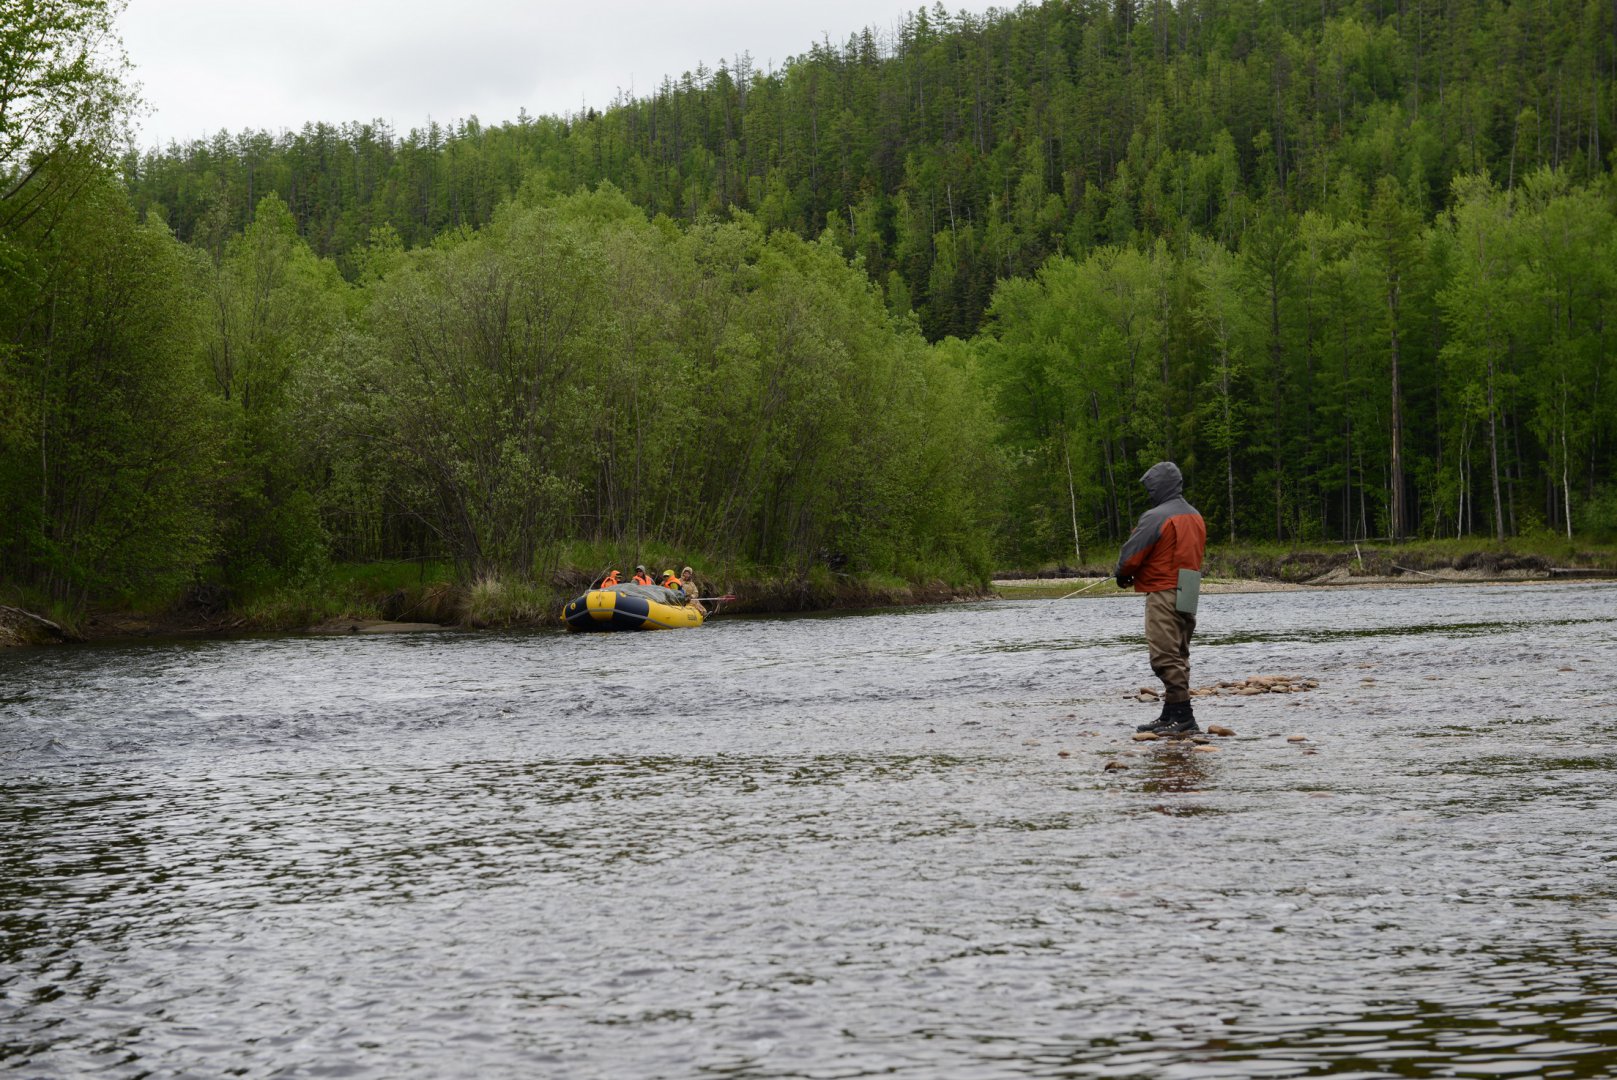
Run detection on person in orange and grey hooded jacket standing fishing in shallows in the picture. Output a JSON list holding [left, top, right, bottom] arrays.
[[1116, 461, 1208, 736]]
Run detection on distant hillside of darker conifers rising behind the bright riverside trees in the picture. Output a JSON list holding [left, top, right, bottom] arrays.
[[126, 0, 1617, 344]]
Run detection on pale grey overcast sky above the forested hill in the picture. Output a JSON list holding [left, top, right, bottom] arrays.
[[121, 0, 1012, 147]]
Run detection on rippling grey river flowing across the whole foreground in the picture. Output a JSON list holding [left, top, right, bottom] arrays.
[[0, 584, 1617, 1080]]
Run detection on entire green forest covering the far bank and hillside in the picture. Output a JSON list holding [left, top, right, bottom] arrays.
[[0, 0, 1617, 620]]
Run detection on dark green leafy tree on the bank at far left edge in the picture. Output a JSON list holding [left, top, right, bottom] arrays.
[[0, 176, 223, 598]]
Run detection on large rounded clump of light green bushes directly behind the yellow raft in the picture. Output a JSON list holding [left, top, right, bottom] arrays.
[[294, 188, 991, 582]]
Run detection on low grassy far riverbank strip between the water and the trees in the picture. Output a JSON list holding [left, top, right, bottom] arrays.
[[0, 538, 1617, 647]]
